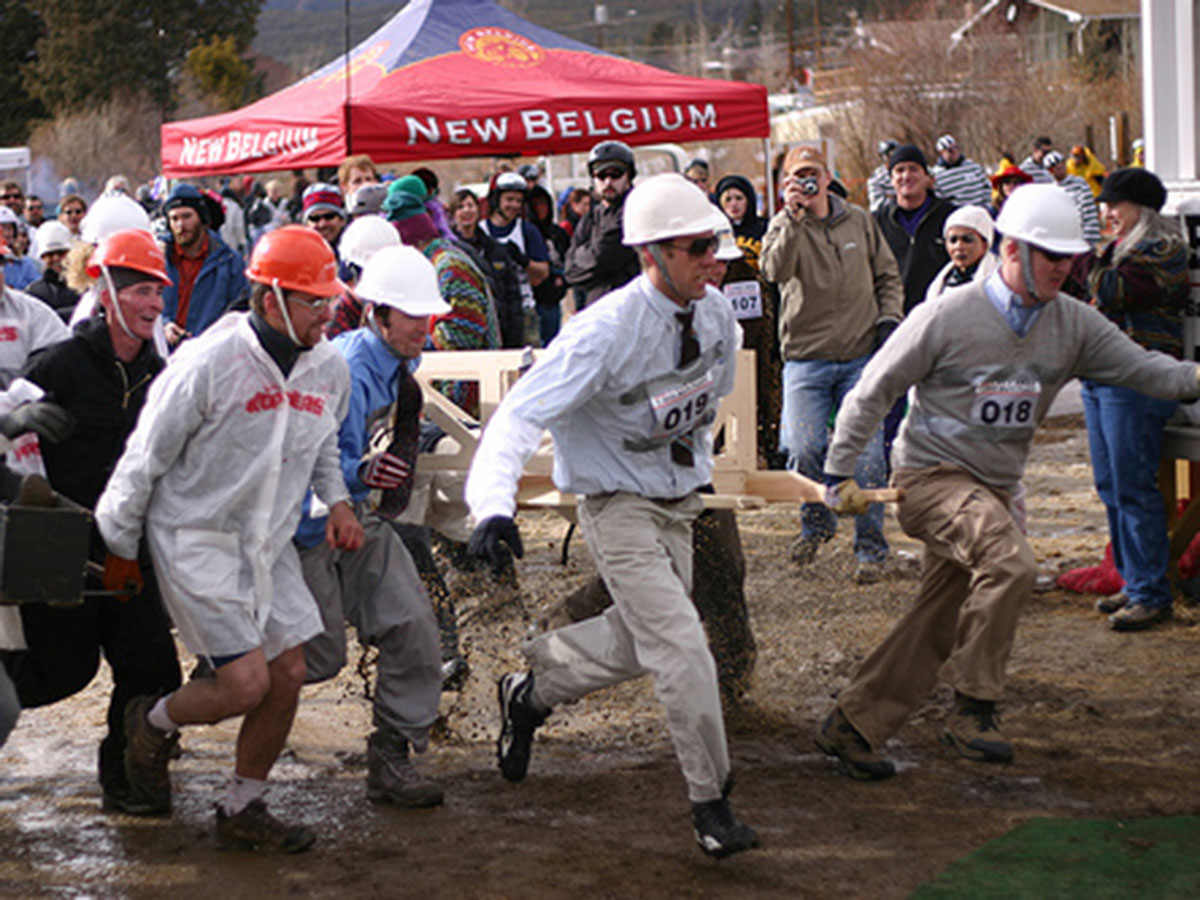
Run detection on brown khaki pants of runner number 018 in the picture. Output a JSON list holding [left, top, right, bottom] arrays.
[[838, 463, 1037, 746]]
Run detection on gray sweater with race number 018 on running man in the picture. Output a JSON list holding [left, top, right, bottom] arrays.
[[826, 282, 1200, 490]]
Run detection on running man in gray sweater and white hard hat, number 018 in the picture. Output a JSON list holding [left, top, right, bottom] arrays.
[[816, 185, 1200, 779]]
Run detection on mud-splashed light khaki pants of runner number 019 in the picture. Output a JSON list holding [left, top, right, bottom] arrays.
[[524, 493, 730, 803]]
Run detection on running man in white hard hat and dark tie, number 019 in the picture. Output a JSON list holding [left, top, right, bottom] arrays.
[[467, 174, 757, 857]]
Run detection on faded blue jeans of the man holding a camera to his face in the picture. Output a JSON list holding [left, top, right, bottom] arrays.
[[780, 355, 888, 563]]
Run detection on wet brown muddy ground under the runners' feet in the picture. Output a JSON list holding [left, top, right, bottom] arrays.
[[0, 418, 1200, 899]]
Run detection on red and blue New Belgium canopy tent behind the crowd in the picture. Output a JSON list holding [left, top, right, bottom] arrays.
[[162, 0, 769, 178]]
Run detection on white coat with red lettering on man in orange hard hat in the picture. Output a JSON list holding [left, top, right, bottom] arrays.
[[96, 313, 350, 659]]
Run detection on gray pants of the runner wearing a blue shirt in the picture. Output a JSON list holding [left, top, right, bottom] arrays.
[[300, 516, 442, 751]]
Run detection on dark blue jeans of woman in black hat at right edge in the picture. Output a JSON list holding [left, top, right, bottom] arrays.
[[1082, 382, 1176, 607]]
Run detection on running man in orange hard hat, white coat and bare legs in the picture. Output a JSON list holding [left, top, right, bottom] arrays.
[[96, 226, 362, 852]]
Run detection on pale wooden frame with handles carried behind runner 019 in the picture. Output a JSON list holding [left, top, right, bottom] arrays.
[[416, 350, 902, 518]]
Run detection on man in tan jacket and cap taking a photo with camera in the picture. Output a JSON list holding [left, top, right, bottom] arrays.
[[762, 146, 904, 583]]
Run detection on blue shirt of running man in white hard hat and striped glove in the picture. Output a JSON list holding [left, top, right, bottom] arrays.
[[295, 328, 416, 548]]
